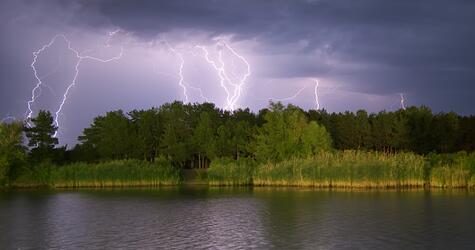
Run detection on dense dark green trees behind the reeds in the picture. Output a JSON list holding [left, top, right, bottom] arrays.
[[0, 102, 475, 187]]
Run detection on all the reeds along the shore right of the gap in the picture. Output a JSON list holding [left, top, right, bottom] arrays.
[[208, 151, 475, 189]]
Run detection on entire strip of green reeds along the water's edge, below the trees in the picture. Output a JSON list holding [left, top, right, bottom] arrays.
[[3, 151, 475, 189]]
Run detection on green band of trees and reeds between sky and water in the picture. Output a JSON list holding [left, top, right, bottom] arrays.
[[0, 102, 475, 189]]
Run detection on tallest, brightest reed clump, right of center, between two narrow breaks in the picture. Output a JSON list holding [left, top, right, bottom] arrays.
[[254, 151, 425, 188]]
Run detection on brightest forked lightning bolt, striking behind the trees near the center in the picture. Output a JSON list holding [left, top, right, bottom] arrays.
[[195, 40, 251, 110]]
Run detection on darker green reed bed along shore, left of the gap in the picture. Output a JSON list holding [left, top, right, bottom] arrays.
[[14, 160, 181, 188]]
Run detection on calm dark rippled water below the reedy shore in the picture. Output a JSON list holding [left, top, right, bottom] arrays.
[[0, 188, 475, 249]]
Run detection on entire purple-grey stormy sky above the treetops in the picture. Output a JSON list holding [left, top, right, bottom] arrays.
[[0, 0, 475, 144]]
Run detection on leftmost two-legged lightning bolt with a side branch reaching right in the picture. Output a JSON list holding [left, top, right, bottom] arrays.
[[26, 30, 124, 137]]
